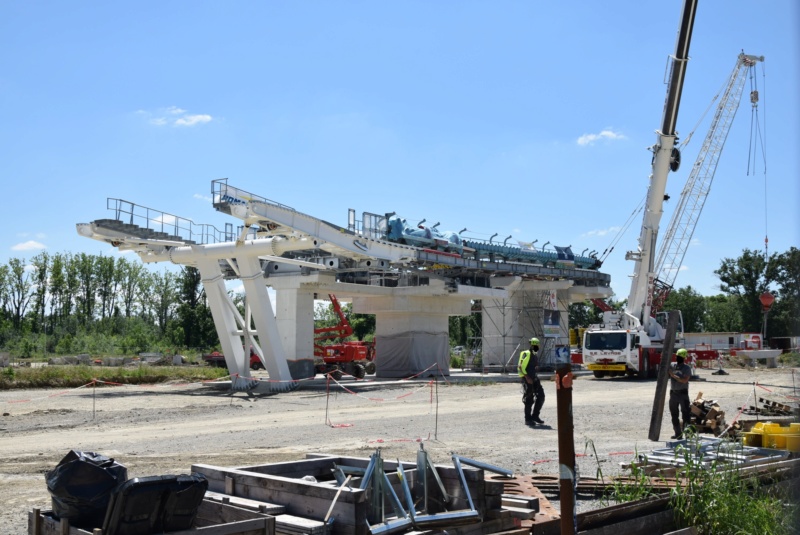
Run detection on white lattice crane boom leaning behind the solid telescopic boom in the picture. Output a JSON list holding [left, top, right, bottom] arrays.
[[653, 52, 764, 312]]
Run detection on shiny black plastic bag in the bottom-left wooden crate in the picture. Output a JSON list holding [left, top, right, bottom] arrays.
[[45, 450, 128, 529]]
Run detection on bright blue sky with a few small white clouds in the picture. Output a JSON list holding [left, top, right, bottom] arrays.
[[0, 0, 800, 299]]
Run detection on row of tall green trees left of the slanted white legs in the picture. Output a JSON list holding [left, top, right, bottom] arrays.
[[0, 252, 219, 357]]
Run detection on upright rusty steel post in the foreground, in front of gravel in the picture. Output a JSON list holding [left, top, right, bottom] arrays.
[[556, 362, 578, 535]]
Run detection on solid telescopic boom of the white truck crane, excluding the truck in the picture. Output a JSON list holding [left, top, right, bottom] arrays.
[[623, 0, 697, 332]]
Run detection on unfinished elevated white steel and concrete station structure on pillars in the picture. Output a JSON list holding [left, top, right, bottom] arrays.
[[77, 179, 611, 391]]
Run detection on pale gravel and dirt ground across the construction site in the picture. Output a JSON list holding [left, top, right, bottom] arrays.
[[0, 368, 800, 535]]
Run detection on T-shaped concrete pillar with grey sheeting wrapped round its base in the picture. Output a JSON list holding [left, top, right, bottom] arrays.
[[353, 295, 470, 378]]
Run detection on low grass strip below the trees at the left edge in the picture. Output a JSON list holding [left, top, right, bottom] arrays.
[[0, 364, 228, 390]]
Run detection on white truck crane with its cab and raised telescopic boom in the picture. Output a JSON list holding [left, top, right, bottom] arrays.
[[583, 0, 697, 377]]
